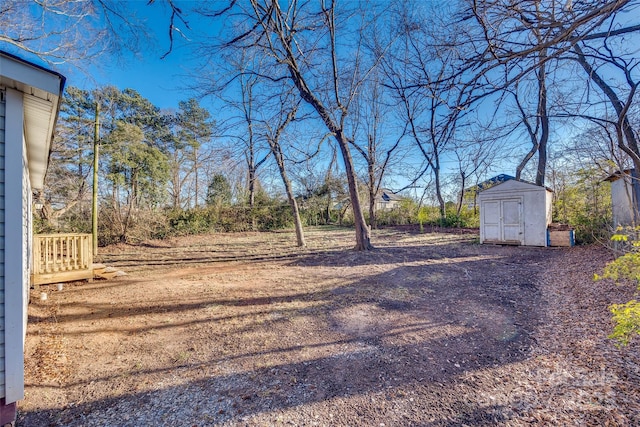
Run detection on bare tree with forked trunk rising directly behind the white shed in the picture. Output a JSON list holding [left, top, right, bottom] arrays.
[[458, 0, 640, 185]]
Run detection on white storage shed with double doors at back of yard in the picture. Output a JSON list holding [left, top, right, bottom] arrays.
[[478, 179, 553, 246]]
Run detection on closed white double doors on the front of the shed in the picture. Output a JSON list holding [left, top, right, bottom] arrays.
[[480, 198, 524, 244]]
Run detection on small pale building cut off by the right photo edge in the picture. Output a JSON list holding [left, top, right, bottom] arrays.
[[604, 169, 640, 227]]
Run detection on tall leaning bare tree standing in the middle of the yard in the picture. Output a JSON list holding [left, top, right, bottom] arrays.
[[201, 0, 390, 250]]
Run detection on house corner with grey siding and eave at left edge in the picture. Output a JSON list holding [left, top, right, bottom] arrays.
[[0, 51, 65, 426]]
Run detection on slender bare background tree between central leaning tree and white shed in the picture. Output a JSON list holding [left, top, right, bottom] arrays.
[[383, 5, 472, 218]]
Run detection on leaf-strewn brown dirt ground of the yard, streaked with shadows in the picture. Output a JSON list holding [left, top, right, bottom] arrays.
[[18, 228, 640, 426]]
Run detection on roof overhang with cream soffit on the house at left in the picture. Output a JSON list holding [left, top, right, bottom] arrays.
[[0, 51, 65, 189]]
